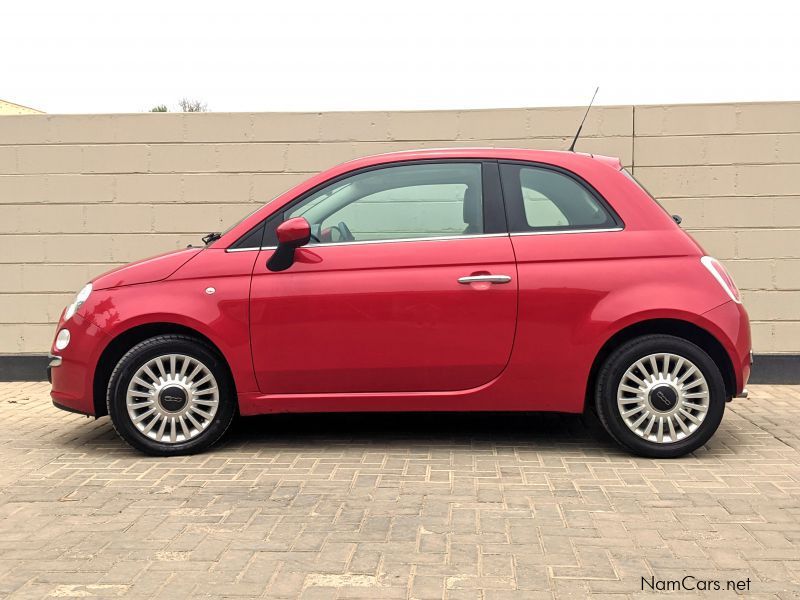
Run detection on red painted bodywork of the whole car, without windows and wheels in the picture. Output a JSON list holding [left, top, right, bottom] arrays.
[[52, 149, 750, 415]]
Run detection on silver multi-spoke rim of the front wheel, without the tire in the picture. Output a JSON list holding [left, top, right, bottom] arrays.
[[125, 354, 219, 444]]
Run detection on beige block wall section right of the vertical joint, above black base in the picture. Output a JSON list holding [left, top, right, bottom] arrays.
[[633, 102, 800, 354]]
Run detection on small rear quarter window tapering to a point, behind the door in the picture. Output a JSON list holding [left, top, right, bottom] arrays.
[[500, 164, 617, 232]]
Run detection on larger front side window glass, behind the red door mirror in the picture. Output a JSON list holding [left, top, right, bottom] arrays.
[[283, 162, 484, 244]]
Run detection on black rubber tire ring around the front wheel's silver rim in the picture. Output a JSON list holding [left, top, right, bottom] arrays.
[[106, 334, 236, 456]]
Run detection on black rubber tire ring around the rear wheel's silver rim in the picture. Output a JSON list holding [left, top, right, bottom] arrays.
[[595, 334, 727, 458]]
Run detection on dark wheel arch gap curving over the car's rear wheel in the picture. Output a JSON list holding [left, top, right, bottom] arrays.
[[584, 318, 736, 408]]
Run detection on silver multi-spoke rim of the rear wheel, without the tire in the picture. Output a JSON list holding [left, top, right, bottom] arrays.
[[617, 353, 709, 444]]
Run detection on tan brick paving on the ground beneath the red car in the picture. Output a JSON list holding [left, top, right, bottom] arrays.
[[0, 383, 800, 600]]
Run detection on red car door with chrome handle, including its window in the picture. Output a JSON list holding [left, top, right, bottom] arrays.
[[250, 160, 517, 394]]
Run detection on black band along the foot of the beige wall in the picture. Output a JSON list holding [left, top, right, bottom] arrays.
[[0, 354, 800, 385]]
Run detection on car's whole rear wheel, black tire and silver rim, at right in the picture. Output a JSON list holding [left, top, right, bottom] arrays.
[[595, 335, 726, 458]]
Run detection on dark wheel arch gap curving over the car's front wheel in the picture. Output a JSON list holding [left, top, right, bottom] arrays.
[[92, 322, 236, 417]]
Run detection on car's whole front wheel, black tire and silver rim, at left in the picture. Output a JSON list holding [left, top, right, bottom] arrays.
[[106, 335, 235, 456]]
